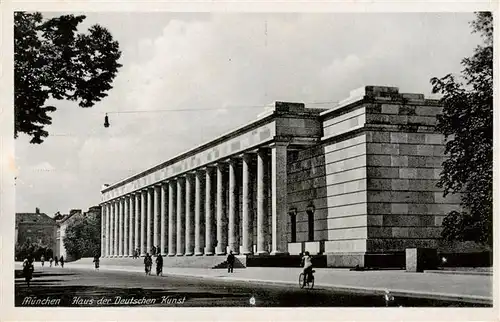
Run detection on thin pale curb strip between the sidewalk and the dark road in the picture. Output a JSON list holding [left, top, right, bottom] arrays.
[[61, 266, 493, 305]]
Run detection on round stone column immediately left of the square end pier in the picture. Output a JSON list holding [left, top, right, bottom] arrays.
[[257, 149, 269, 254]]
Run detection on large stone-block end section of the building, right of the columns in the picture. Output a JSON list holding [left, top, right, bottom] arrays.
[[288, 86, 472, 266]]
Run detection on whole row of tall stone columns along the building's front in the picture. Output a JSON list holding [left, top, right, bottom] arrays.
[[101, 144, 287, 257]]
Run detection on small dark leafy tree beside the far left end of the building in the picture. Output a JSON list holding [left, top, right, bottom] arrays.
[[63, 214, 101, 259]]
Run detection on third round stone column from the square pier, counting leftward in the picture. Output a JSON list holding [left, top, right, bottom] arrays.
[[228, 159, 240, 254]]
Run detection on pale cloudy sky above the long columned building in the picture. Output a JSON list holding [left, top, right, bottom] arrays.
[[15, 12, 480, 216]]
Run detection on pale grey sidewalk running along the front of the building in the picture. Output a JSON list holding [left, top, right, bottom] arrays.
[[55, 263, 493, 304]]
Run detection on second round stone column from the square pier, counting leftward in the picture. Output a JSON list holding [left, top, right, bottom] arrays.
[[241, 154, 253, 255]]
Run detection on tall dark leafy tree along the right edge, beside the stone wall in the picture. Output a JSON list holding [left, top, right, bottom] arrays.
[[431, 12, 493, 247]]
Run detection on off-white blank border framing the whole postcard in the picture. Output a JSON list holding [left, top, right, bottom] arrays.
[[0, 0, 500, 321]]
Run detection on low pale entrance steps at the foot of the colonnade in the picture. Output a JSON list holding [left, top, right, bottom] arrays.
[[75, 255, 246, 269]]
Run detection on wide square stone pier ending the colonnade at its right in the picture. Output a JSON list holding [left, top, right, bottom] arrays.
[[271, 142, 288, 255]]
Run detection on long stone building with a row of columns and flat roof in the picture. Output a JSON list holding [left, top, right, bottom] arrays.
[[101, 86, 486, 267]]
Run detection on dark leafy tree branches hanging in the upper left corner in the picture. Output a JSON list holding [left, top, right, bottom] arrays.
[[14, 12, 122, 144]]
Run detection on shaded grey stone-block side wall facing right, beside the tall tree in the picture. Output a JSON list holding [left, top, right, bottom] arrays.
[[365, 94, 460, 253]]
